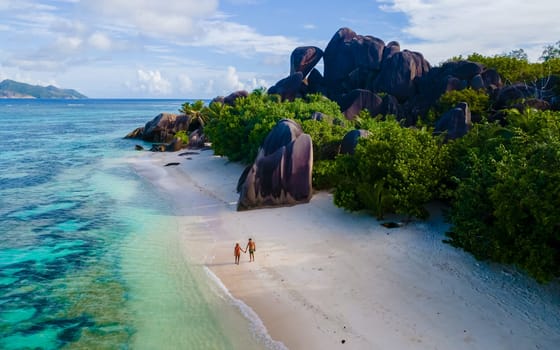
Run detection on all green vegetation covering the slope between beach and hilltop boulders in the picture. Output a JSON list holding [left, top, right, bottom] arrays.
[[187, 43, 560, 282]]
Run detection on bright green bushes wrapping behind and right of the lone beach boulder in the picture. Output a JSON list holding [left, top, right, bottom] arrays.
[[205, 93, 448, 218]]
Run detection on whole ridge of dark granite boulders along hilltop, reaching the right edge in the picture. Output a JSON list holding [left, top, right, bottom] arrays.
[[268, 28, 560, 126]]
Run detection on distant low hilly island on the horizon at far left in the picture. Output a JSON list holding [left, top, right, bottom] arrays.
[[0, 79, 87, 99]]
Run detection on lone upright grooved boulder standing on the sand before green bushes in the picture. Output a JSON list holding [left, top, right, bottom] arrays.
[[237, 119, 313, 210]]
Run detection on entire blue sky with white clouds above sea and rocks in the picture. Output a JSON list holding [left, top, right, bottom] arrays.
[[0, 0, 560, 99]]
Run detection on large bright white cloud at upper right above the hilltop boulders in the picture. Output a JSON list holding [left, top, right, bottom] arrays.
[[378, 0, 560, 63]]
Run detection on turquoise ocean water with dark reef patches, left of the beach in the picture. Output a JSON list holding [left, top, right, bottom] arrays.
[[0, 100, 278, 349]]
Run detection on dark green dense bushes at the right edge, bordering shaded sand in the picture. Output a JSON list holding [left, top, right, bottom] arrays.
[[449, 111, 560, 281]]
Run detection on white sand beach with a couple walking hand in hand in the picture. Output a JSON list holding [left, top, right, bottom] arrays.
[[131, 150, 560, 349]]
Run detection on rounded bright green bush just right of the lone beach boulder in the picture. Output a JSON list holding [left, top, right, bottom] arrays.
[[334, 118, 448, 218]]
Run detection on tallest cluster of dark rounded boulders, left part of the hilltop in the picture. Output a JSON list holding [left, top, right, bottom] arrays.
[[268, 28, 431, 119]]
